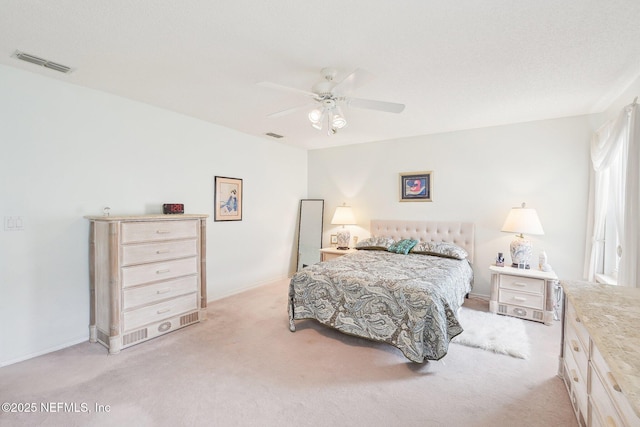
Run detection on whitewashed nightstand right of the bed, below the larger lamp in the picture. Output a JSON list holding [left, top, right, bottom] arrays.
[[489, 265, 558, 325]]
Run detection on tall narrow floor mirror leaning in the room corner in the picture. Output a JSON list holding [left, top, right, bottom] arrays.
[[297, 199, 324, 271]]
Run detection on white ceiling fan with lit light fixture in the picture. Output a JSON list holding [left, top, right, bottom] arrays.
[[258, 68, 404, 135]]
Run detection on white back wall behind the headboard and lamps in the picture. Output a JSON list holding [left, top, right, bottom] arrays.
[[309, 116, 595, 296]]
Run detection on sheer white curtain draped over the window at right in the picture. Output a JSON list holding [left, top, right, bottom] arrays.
[[584, 101, 640, 287]]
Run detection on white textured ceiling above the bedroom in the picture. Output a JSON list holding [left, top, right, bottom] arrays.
[[0, 0, 640, 149]]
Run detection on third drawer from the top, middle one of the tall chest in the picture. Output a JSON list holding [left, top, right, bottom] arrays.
[[122, 257, 198, 288]]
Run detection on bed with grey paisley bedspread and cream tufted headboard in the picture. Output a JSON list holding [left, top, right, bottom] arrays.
[[288, 220, 474, 363]]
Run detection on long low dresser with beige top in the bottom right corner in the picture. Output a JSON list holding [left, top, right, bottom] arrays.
[[558, 281, 640, 426]]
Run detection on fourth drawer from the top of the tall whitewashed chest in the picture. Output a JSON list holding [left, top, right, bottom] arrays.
[[122, 275, 198, 310]]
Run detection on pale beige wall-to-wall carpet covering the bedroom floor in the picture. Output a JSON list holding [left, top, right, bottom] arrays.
[[0, 278, 577, 427]]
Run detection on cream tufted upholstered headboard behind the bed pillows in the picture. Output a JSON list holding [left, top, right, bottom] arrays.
[[369, 219, 475, 262]]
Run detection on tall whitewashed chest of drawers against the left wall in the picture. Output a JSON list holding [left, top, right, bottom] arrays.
[[85, 214, 208, 354]]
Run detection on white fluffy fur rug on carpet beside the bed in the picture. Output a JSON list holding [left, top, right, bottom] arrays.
[[451, 307, 529, 359]]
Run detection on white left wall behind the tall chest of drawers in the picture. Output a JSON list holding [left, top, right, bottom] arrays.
[[0, 66, 307, 366]]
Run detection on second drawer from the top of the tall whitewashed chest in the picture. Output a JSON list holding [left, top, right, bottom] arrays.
[[122, 239, 198, 266]]
